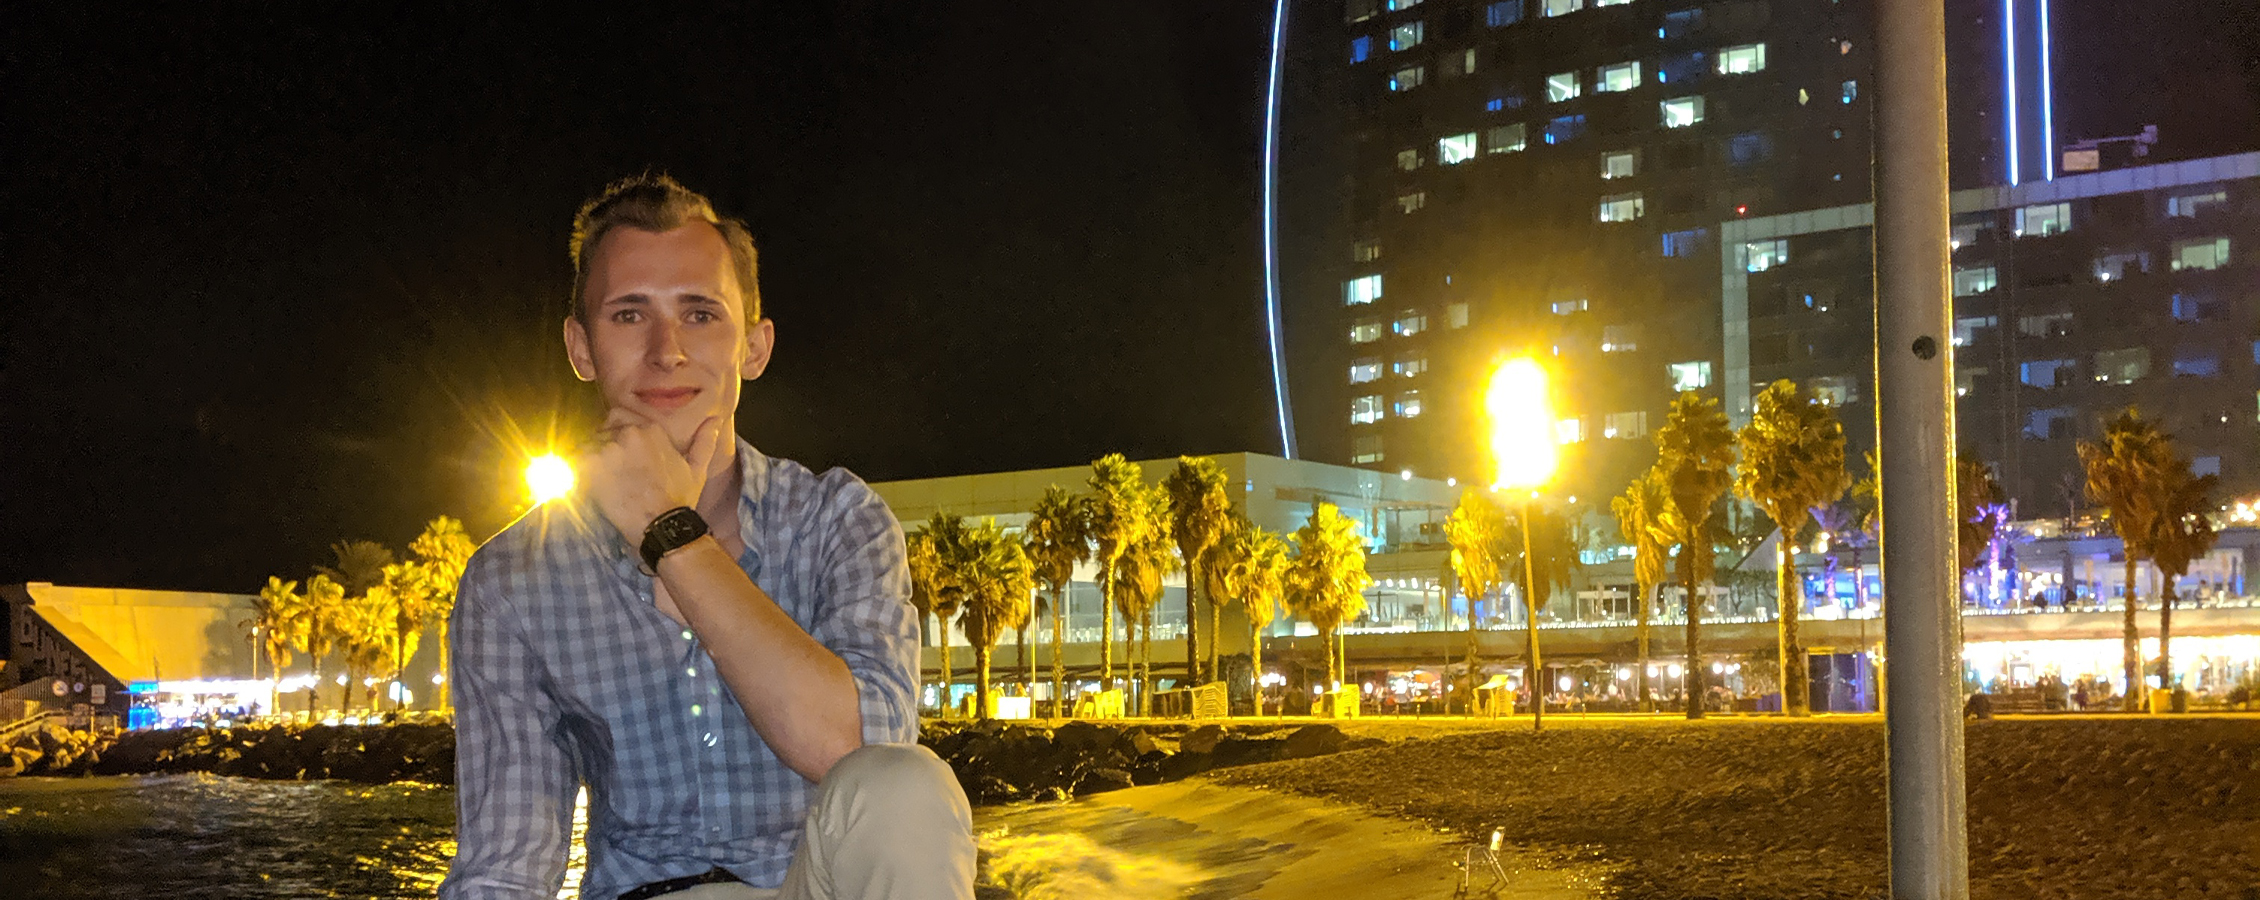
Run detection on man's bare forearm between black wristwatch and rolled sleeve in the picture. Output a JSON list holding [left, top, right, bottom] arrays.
[[660, 536, 863, 780]]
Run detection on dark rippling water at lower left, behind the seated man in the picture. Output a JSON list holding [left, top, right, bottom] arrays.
[[0, 776, 581, 900]]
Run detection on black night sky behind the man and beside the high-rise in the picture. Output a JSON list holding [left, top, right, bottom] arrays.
[[0, 0, 2260, 592]]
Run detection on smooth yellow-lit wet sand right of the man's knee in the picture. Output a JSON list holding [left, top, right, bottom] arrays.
[[974, 778, 1602, 900]]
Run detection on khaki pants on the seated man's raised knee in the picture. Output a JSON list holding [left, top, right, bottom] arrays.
[[664, 744, 974, 900]]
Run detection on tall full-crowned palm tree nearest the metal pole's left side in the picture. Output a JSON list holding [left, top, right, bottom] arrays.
[[1733, 380, 1851, 715]]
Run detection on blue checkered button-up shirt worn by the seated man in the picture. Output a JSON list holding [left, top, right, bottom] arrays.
[[438, 441, 918, 900]]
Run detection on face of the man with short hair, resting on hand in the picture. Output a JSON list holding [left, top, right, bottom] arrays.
[[565, 222, 775, 448]]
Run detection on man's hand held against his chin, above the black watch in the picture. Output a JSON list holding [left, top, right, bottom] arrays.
[[576, 409, 721, 547]]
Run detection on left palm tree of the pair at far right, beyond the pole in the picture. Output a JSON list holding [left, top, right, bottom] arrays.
[[2079, 407, 2172, 712]]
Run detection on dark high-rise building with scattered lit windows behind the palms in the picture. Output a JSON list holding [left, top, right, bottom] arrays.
[[1293, 0, 2260, 516]]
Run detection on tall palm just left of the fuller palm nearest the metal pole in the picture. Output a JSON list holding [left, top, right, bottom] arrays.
[[1657, 391, 1733, 719]]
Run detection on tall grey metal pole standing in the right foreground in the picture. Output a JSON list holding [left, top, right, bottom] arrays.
[[1874, 0, 1968, 900]]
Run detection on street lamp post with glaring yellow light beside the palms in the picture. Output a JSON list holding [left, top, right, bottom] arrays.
[[1483, 357, 1555, 730]]
